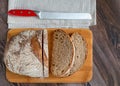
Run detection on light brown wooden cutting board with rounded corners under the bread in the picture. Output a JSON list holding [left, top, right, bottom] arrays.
[[6, 28, 93, 83]]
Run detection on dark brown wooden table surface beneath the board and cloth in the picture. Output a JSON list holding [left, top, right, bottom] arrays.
[[0, 0, 120, 86]]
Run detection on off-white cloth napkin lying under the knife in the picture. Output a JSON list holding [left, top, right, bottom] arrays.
[[8, 0, 96, 28]]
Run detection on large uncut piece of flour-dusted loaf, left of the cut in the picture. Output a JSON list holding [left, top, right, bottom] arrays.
[[4, 30, 43, 77]]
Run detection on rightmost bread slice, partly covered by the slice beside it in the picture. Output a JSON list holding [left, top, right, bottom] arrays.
[[67, 32, 87, 75]]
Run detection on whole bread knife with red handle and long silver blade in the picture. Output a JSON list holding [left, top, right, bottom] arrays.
[[8, 9, 92, 20]]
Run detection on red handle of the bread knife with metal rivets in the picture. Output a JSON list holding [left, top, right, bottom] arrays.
[[8, 9, 37, 17]]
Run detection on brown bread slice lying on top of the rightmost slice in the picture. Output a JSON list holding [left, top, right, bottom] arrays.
[[51, 29, 74, 77]]
